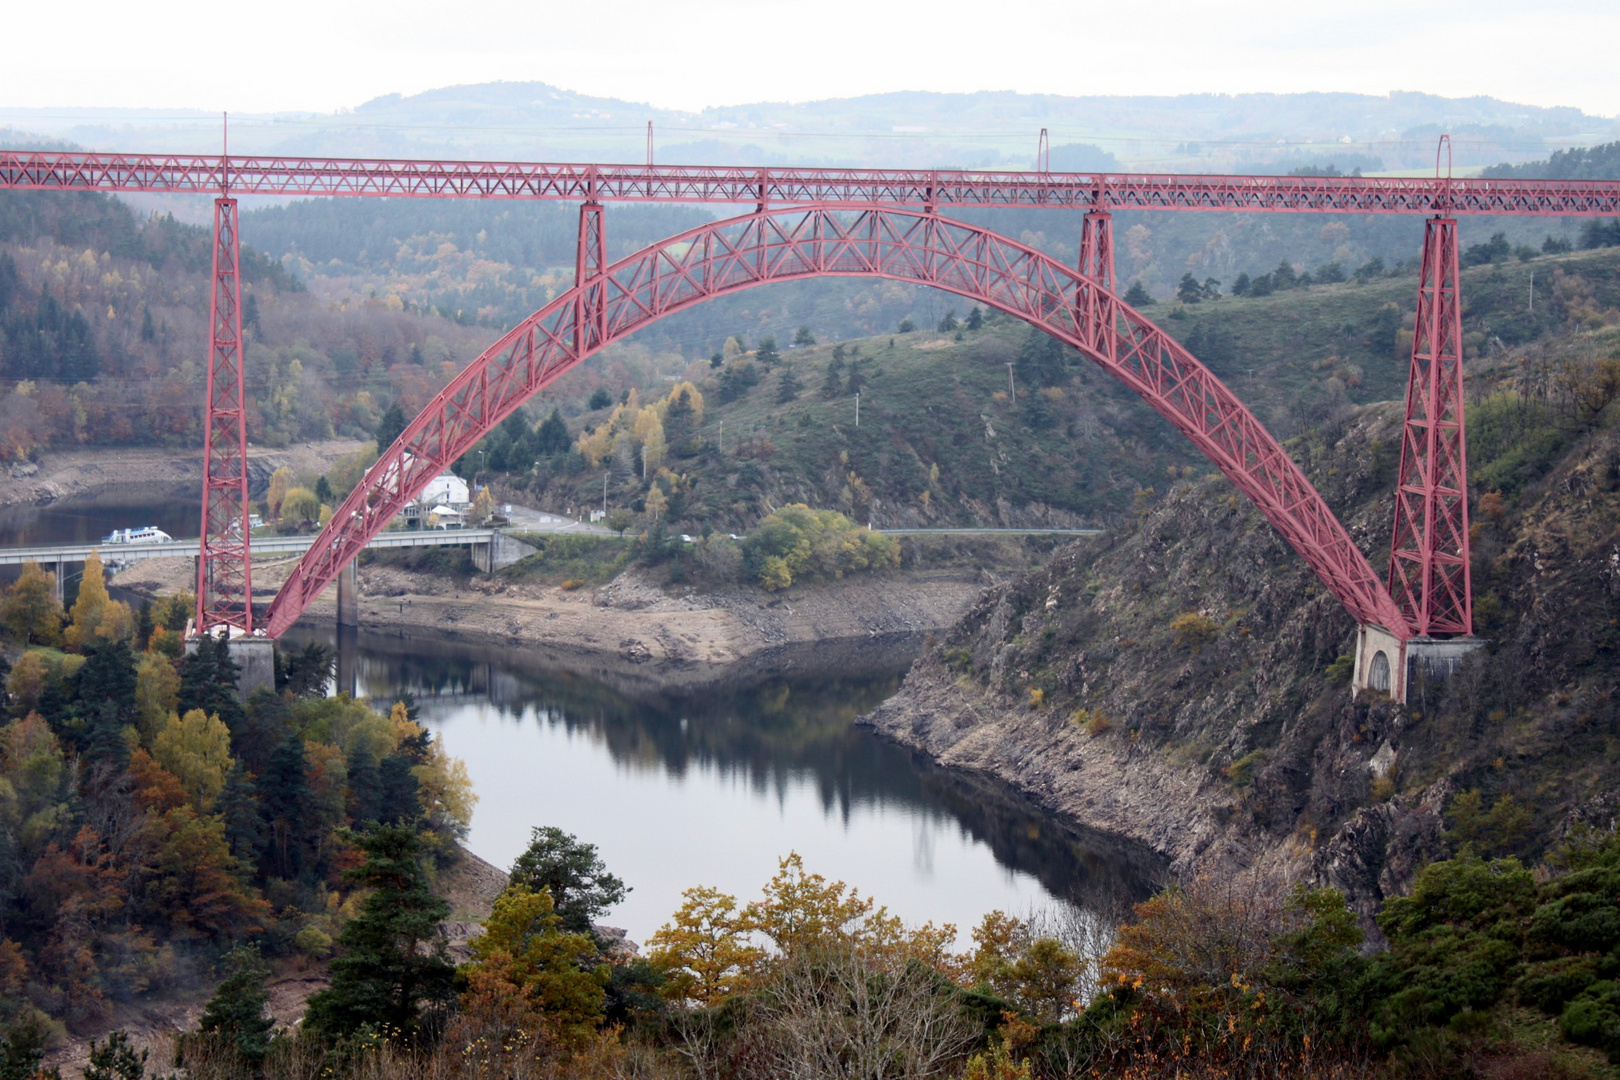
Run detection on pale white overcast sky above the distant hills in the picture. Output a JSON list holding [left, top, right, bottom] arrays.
[[12, 0, 1620, 115]]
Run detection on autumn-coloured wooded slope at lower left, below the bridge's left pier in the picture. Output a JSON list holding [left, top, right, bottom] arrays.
[[0, 555, 475, 1049]]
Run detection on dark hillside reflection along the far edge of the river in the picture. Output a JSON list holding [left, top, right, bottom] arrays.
[[287, 631, 1165, 942]]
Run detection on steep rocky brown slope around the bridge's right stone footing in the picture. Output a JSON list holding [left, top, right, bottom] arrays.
[[867, 368, 1620, 932]]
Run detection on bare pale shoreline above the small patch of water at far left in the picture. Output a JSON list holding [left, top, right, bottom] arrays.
[[0, 439, 366, 507]]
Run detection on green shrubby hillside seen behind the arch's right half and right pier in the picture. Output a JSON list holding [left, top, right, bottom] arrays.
[[458, 243, 1620, 534]]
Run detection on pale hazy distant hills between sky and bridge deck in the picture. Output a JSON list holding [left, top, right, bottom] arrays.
[[0, 83, 1620, 172]]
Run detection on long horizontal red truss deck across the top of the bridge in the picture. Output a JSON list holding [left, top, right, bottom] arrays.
[[0, 151, 1620, 215]]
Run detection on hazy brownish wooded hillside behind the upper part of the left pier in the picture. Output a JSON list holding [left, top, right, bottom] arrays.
[[0, 193, 486, 460]]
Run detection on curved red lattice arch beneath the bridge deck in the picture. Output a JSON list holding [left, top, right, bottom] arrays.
[[266, 202, 1411, 640]]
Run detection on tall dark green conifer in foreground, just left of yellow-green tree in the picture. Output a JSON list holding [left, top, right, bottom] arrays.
[[305, 826, 455, 1041]]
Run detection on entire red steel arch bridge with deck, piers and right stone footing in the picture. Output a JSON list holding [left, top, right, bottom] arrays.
[[0, 145, 1620, 699]]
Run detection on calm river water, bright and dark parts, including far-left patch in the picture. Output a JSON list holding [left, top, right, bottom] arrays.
[[0, 495, 1160, 946]]
